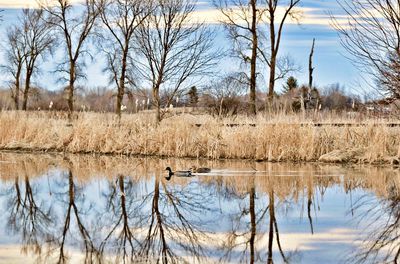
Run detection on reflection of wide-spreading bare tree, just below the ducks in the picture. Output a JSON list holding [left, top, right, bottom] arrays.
[[139, 175, 212, 263]]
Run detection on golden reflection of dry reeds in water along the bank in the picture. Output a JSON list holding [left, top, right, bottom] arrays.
[[0, 153, 400, 199]]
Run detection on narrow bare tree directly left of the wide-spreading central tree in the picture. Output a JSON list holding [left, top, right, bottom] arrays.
[[100, 0, 151, 117]]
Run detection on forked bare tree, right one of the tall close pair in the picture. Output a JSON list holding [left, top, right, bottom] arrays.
[[267, 0, 300, 106]]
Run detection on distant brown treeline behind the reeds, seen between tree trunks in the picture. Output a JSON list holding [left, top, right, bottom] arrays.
[[0, 76, 366, 116]]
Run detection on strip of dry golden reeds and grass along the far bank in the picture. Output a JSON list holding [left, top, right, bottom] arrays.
[[0, 111, 400, 163]]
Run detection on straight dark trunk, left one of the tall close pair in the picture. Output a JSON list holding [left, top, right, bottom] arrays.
[[250, 0, 258, 115]]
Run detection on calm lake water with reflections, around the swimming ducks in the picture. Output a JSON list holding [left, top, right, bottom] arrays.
[[0, 153, 400, 263]]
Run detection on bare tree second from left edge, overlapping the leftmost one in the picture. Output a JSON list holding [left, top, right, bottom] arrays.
[[21, 9, 55, 110]]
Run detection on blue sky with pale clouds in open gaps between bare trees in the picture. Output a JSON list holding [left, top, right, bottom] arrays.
[[0, 0, 362, 93]]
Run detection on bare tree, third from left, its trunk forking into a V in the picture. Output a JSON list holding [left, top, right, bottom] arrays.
[[39, 0, 100, 116]]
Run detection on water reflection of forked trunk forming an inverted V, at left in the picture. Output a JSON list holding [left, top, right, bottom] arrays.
[[58, 170, 97, 263]]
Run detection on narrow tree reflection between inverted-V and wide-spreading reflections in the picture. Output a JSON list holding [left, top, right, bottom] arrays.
[[99, 175, 139, 262]]
